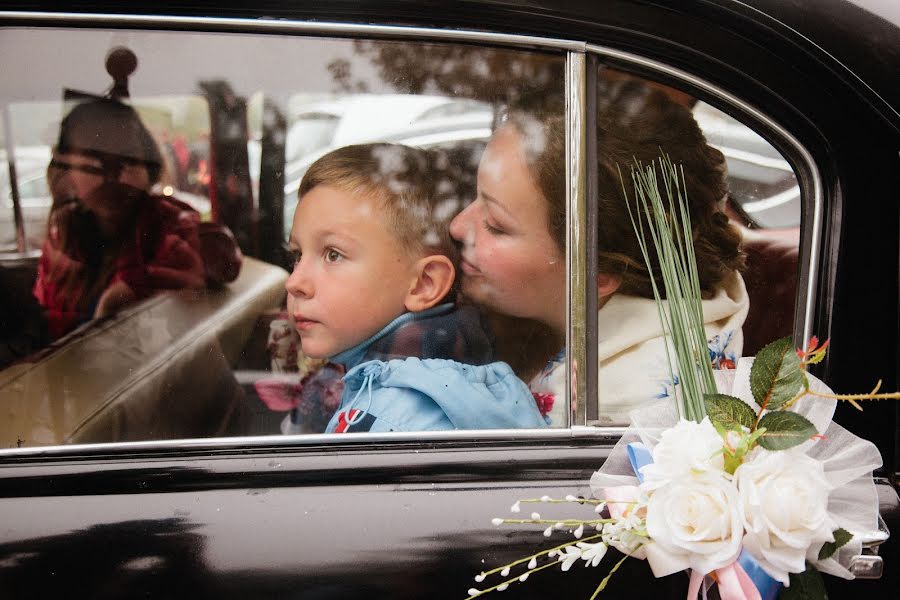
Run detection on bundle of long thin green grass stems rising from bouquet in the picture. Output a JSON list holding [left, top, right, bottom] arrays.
[[619, 154, 716, 421]]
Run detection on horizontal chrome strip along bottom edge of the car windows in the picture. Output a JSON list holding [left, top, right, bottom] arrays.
[[0, 427, 626, 466]]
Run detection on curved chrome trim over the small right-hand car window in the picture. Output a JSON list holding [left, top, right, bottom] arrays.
[[586, 44, 824, 341]]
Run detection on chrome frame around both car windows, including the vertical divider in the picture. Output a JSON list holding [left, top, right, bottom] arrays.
[[0, 11, 823, 459]]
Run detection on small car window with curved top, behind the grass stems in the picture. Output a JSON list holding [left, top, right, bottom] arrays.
[[594, 68, 801, 425]]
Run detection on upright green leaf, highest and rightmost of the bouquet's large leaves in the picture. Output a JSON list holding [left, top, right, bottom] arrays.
[[750, 338, 803, 410]]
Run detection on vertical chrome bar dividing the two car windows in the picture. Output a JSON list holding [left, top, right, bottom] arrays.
[[561, 52, 589, 427]]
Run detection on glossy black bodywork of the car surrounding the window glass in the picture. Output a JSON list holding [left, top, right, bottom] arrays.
[[0, 0, 900, 598]]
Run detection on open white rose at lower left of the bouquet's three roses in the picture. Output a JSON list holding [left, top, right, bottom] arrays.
[[647, 472, 743, 576]]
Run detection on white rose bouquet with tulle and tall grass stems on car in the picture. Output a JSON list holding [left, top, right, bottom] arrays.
[[469, 157, 900, 600]]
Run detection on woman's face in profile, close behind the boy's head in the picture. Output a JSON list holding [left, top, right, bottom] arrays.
[[450, 124, 566, 334]]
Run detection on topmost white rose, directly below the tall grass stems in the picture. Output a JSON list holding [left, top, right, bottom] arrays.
[[641, 417, 725, 489]]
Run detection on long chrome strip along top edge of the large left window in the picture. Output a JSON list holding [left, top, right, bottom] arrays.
[[0, 11, 585, 52]]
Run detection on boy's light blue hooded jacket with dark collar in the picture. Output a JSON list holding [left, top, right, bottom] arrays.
[[326, 304, 548, 433]]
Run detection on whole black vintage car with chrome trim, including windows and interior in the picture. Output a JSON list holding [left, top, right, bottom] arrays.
[[0, 0, 900, 598]]
